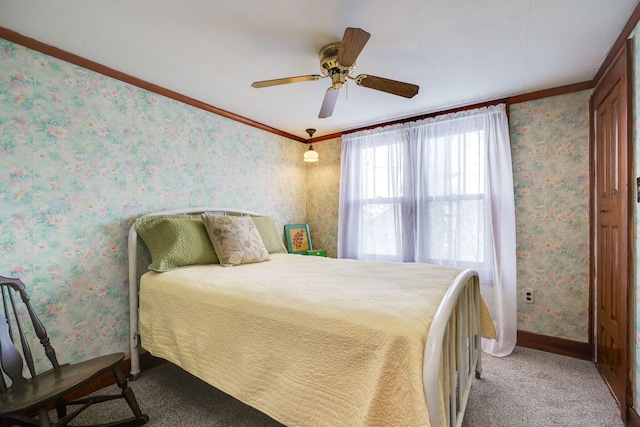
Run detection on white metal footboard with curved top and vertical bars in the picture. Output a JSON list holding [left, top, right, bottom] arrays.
[[423, 270, 482, 427]]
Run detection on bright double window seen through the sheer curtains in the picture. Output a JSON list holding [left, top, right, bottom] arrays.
[[351, 130, 485, 266]]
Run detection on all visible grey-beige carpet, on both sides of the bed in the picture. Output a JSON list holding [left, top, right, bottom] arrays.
[[69, 347, 623, 427]]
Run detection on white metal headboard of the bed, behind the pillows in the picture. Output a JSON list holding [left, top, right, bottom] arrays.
[[128, 206, 262, 377]]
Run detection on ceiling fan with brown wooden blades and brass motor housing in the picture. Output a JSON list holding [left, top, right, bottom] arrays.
[[251, 28, 420, 119]]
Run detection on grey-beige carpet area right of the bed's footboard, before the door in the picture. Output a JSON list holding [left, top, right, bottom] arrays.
[[462, 347, 624, 427]]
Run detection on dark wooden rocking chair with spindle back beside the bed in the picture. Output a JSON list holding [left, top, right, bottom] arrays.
[[0, 276, 149, 426]]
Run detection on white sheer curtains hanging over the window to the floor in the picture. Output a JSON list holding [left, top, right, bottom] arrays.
[[338, 104, 517, 356]]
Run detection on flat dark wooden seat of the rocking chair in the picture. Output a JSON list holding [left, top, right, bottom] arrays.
[[0, 353, 125, 415]]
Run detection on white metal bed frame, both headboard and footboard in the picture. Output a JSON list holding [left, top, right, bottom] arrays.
[[128, 207, 482, 427]]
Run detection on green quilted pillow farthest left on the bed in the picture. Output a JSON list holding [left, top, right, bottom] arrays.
[[136, 215, 219, 272]]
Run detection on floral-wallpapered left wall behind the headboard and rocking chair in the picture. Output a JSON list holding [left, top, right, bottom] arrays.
[[0, 39, 306, 361]]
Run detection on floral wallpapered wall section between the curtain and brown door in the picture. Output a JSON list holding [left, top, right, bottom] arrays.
[[510, 91, 591, 342]]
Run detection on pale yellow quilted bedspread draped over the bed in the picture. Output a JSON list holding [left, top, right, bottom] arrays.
[[140, 254, 484, 427]]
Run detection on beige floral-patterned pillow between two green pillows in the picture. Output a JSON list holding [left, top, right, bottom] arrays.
[[202, 214, 270, 267]]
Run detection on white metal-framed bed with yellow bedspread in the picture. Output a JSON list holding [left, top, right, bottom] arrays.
[[129, 207, 495, 426]]
